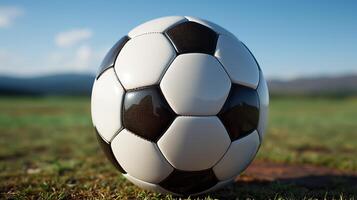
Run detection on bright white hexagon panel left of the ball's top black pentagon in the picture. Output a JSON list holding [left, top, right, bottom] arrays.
[[114, 33, 176, 90]]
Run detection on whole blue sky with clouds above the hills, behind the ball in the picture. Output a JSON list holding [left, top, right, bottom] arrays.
[[0, 0, 357, 78]]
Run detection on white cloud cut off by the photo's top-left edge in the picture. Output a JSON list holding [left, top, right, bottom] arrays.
[[0, 6, 24, 28]]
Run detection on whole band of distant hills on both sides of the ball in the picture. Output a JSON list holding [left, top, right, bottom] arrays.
[[0, 74, 357, 95]]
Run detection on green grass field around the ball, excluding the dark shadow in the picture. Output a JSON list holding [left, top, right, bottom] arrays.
[[0, 97, 357, 199]]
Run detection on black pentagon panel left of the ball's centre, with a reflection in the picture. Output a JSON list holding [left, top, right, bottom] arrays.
[[123, 86, 176, 142]]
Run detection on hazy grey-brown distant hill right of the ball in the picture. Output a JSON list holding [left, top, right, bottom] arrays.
[[268, 75, 357, 95]]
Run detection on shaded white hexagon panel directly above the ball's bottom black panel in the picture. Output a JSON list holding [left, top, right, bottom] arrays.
[[157, 116, 231, 171]]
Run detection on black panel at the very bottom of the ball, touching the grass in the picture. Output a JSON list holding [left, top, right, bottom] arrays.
[[159, 169, 218, 195]]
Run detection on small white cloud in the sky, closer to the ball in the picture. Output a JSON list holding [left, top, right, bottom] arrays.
[[55, 28, 93, 47]]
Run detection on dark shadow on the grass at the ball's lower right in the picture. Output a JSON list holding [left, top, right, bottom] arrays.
[[193, 175, 357, 199]]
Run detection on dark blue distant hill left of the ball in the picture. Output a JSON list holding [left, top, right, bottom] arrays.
[[0, 74, 95, 95]]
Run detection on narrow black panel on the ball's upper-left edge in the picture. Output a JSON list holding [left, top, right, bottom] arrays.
[[97, 36, 130, 79]]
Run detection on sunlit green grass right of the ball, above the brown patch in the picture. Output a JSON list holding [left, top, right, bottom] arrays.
[[258, 97, 357, 171]]
